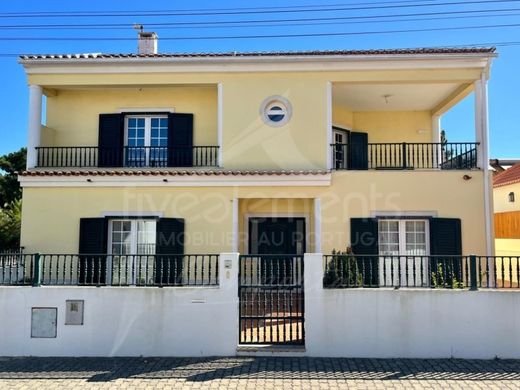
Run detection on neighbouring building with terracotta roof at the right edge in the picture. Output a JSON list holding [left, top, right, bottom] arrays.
[[493, 163, 520, 256]]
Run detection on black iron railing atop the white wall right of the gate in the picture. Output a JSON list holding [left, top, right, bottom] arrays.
[[323, 254, 520, 289]]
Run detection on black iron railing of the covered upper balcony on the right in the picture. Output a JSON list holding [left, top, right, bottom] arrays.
[[331, 142, 478, 170]]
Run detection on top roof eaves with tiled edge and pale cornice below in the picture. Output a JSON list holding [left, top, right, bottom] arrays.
[[19, 48, 497, 74]]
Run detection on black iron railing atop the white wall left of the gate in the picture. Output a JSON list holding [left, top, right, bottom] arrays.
[[0, 254, 219, 287]]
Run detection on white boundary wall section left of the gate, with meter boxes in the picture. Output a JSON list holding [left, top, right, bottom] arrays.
[[0, 254, 238, 356]]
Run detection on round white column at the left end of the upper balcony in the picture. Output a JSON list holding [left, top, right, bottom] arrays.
[[27, 85, 43, 169]]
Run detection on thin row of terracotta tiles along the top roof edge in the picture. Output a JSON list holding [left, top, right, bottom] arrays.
[[19, 47, 495, 61]]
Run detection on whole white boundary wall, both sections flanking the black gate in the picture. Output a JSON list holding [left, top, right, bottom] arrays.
[[0, 253, 520, 359]]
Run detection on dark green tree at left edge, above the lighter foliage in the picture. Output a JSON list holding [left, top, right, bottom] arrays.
[[0, 148, 27, 207]]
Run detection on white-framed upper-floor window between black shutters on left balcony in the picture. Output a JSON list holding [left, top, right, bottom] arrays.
[[125, 115, 168, 167]]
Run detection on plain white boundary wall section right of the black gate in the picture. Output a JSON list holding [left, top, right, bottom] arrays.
[[305, 254, 520, 359]]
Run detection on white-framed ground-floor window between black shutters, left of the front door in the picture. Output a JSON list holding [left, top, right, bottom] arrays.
[[108, 219, 157, 285]]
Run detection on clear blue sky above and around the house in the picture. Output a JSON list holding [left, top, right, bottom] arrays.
[[0, 0, 520, 158]]
